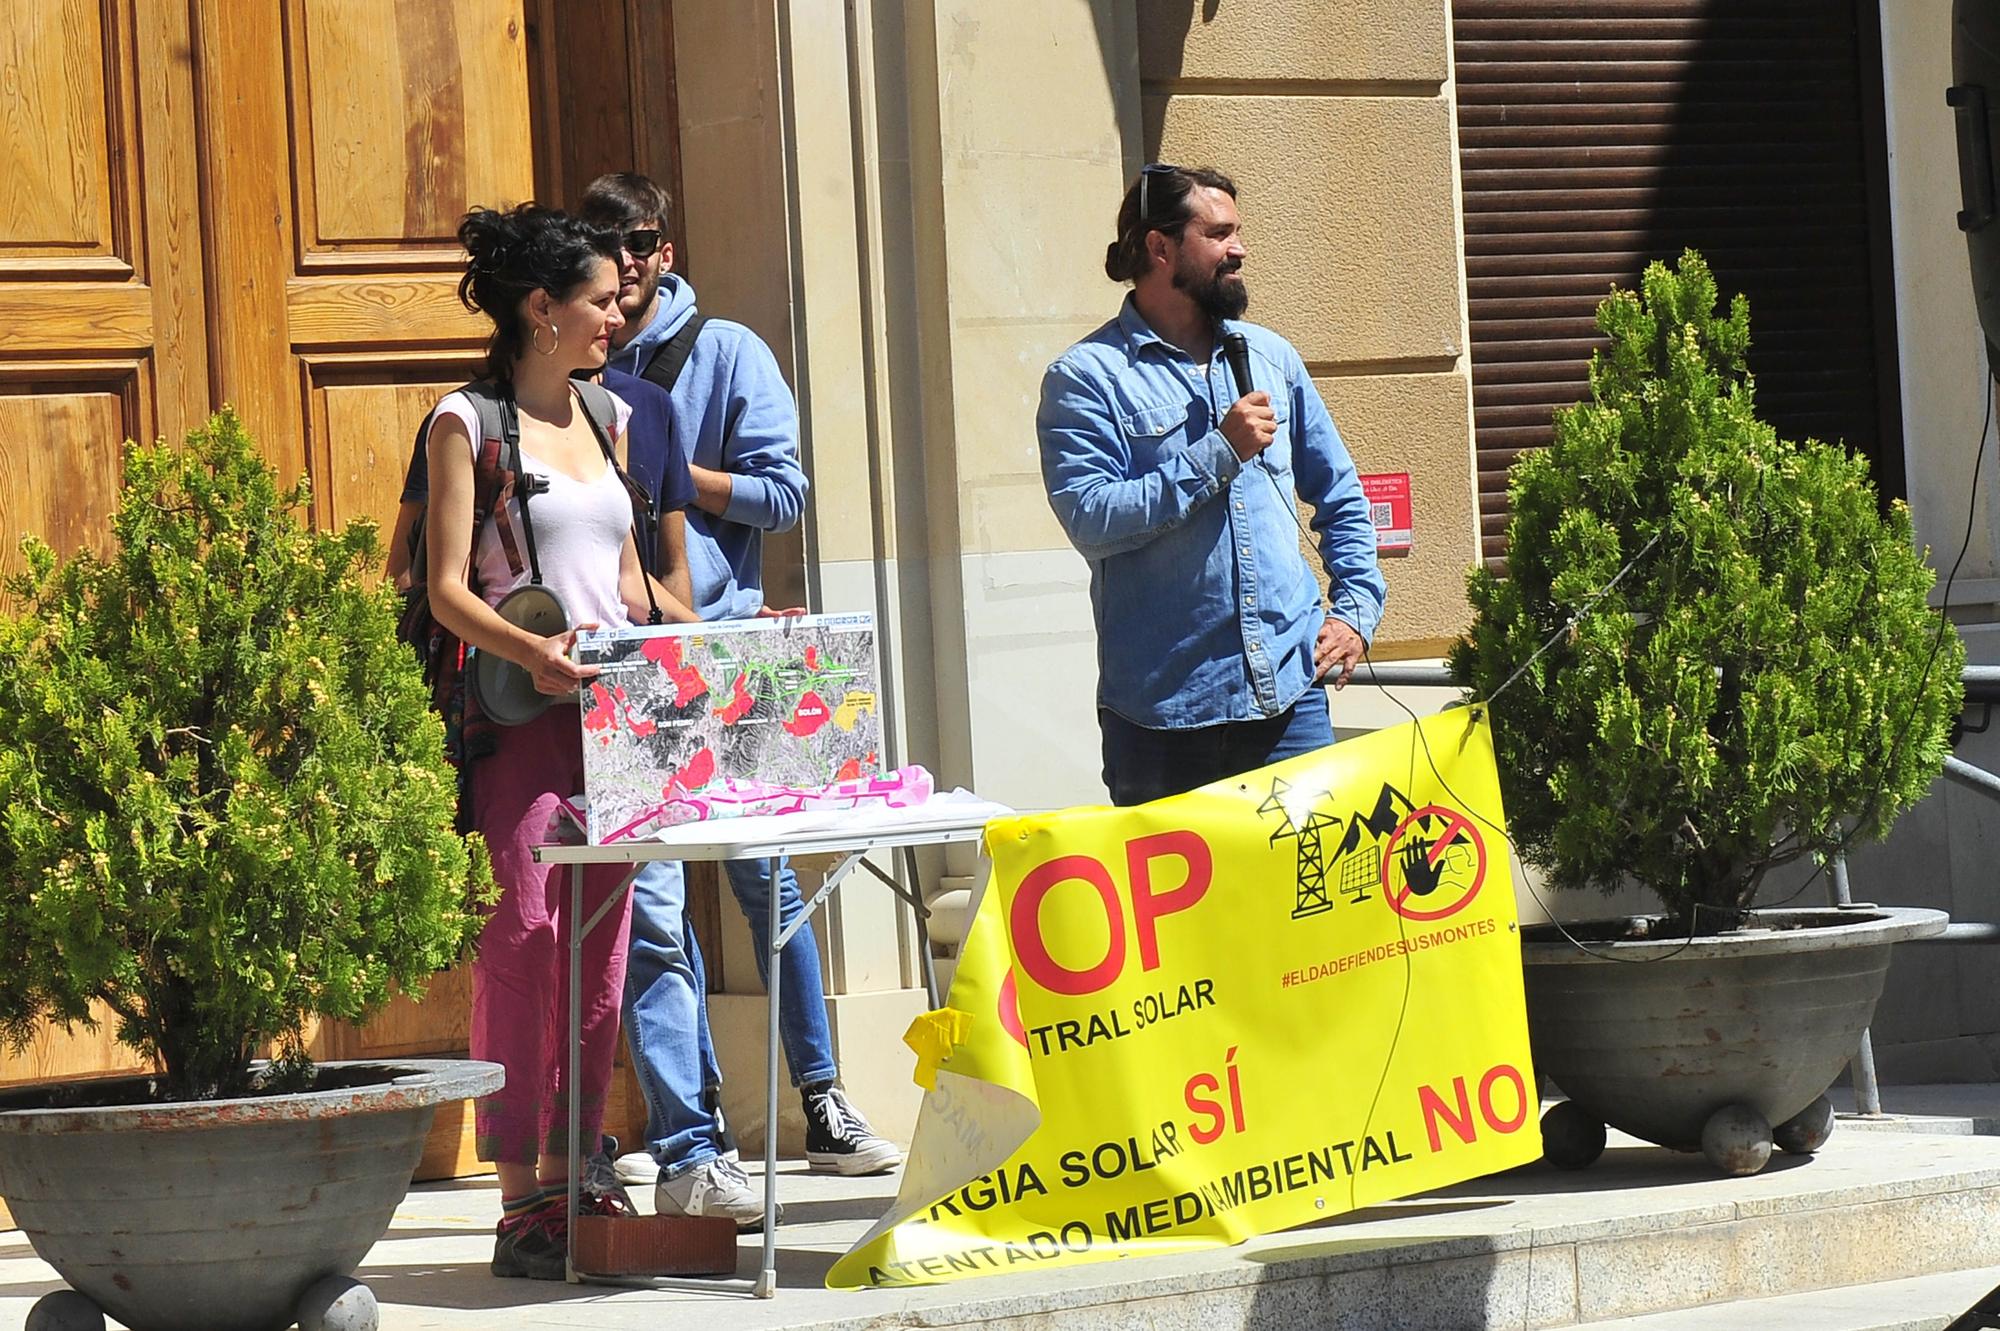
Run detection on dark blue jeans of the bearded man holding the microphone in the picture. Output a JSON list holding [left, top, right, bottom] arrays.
[[1098, 685, 1334, 805]]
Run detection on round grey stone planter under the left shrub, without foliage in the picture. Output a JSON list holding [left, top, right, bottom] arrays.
[[0, 1059, 504, 1331]]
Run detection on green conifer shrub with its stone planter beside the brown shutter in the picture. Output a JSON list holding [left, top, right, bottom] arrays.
[[1450, 252, 1964, 1173]]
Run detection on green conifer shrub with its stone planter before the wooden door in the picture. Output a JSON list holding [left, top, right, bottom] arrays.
[[0, 410, 500, 1331]]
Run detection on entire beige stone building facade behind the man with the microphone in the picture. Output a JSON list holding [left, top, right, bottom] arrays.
[[660, 0, 2000, 1131]]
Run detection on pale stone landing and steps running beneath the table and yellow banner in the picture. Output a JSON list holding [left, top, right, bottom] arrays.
[[0, 1131, 2000, 1331]]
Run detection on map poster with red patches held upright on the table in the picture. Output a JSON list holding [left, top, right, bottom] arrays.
[[576, 614, 882, 845]]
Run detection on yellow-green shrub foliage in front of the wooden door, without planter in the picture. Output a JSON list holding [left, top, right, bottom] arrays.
[[0, 412, 492, 1099]]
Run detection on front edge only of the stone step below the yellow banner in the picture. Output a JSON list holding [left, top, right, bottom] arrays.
[[794, 1169, 2000, 1331]]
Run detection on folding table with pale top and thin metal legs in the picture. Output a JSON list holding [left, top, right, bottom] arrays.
[[534, 799, 1008, 1299]]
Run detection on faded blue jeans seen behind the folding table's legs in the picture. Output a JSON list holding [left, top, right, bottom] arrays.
[[624, 859, 836, 1177]]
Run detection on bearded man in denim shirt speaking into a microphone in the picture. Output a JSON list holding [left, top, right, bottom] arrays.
[[1036, 166, 1386, 803]]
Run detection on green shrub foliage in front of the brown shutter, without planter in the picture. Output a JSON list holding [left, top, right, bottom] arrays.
[[1452, 252, 1964, 931]]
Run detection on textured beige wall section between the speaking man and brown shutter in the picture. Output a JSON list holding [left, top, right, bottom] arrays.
[[1144, 0, 1478, 655]]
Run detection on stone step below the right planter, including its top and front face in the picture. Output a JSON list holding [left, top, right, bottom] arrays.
[[776, 1131, 2000, 1331]]
